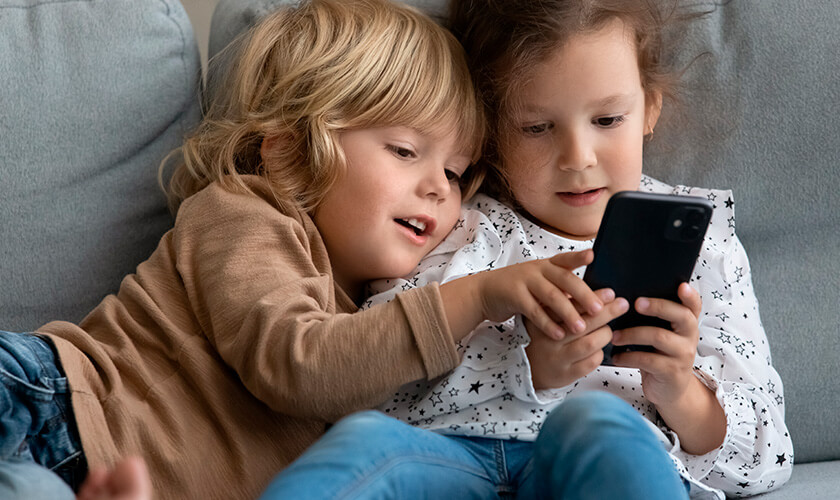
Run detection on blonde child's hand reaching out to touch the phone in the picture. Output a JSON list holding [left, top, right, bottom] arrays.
[[473, 250, 604, 340]]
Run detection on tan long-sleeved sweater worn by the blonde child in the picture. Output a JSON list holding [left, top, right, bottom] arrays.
[[39, 178, 458, 499]]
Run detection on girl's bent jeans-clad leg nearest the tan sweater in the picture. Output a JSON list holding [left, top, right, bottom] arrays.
[[261, 411, 496, 500]]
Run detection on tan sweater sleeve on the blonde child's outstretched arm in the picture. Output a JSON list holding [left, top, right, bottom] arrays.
[[175, 186, 458, 421]]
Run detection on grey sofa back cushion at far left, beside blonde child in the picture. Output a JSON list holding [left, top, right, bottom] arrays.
[[0, 0, 200, 331]]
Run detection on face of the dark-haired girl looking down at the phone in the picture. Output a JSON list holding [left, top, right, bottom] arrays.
[[504, 21, 659, 243]]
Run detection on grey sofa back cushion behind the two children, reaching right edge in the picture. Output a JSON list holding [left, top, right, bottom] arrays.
[[205, 0, 840, 462]]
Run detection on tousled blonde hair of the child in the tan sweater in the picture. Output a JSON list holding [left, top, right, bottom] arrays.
[[161, 0, 485, 212]]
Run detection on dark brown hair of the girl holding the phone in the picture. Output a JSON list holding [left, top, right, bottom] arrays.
[[449, 0, 688, 202]]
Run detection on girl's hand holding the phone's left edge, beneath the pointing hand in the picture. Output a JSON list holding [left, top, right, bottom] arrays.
[[525, 289, 629, 390]]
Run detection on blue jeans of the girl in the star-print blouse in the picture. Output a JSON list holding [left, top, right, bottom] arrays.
[[261, 392, 688, 500]]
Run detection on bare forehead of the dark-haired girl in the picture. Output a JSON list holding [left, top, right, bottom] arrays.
[[522, 20, 641, 109]]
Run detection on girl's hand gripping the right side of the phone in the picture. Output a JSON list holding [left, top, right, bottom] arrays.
[[612, 283, 702, 407]]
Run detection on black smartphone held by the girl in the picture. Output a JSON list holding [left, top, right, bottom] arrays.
[[583, 191, 712, 365]]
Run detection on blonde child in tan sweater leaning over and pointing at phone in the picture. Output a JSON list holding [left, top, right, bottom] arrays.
[[0, 0, 608, 499]]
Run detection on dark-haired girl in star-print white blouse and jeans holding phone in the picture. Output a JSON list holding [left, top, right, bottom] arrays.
[[265, 0, 793, 499]]
